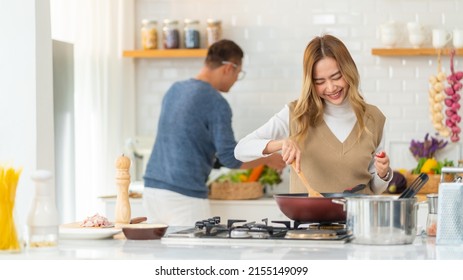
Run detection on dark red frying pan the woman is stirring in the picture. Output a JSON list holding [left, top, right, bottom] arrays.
[[273, 184, 366, 223]]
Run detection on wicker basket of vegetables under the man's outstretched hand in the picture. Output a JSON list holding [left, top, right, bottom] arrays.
[[209, 182, 264, 200]]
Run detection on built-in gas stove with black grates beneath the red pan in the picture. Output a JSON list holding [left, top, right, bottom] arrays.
[[161, 217, 352, 246]]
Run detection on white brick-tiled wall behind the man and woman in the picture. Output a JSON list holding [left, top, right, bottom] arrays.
[[134, 0, 463, 170]]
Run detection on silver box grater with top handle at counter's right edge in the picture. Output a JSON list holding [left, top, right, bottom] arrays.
[[436, 167, 463, 245]]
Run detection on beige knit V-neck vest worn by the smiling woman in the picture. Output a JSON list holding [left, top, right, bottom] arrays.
[[289, 101, 386, 194]]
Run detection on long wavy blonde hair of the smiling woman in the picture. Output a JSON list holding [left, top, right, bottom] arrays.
[[293, 35, 366, 142]]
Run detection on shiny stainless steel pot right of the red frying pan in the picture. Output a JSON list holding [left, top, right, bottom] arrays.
[[333, 195, 418, 245]]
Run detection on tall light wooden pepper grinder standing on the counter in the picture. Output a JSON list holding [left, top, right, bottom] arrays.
[[115, 154, 131, 228]]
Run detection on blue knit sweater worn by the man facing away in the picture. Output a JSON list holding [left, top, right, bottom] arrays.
[[143, 79, 242, 198]]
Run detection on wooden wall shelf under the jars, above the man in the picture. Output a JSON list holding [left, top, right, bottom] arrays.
[[123, 49, 207, 58]]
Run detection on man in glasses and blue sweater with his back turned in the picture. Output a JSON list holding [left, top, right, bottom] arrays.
[[143, 40, 286, 226]]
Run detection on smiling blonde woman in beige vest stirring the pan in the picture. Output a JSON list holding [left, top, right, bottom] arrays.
[[235, 35, 392, 194]]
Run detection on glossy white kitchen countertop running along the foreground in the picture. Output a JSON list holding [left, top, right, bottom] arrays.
[[0, 232, 463, 260]]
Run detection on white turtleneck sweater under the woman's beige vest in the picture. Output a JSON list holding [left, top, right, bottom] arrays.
[[235, 100, 392, 193]]
